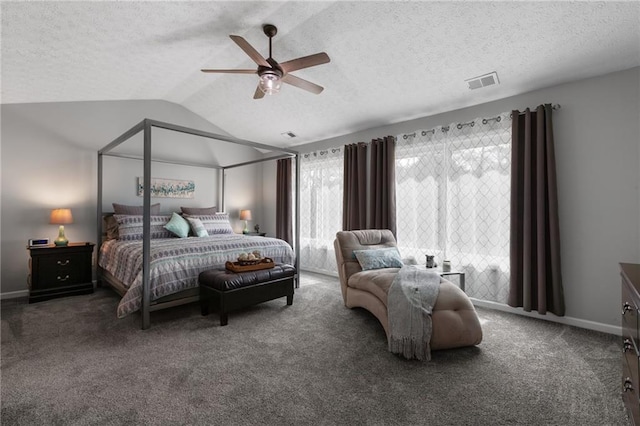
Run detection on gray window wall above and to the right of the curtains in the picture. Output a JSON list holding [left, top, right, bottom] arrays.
[[276, 68, 640, 332]]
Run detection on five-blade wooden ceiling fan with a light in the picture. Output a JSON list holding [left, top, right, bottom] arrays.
[[201, 24, 330, 99]]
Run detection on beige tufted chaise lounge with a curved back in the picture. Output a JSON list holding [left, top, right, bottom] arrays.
[[334, 229, 482, 350]]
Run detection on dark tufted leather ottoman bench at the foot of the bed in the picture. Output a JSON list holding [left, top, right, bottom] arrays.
[[198, 264, 296, 325]]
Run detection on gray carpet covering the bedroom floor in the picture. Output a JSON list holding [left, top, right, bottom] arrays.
[[1, 274, 628, 426]]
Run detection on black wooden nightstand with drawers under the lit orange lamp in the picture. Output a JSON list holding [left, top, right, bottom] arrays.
[[29, 243, 94, 303]]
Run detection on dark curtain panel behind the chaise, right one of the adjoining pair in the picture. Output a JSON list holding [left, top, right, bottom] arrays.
[[368, 136, 396, 236]]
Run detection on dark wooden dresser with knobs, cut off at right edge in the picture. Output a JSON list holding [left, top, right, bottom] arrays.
[[620, 263, 640, 426]]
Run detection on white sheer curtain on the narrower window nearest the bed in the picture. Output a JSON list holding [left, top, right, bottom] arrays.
[[300, 148, 344, 275]]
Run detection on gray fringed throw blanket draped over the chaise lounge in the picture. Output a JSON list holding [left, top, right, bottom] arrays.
[[387, 265, 440, 360]]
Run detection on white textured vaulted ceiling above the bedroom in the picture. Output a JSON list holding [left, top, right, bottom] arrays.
[[1, 1, 640, 146]]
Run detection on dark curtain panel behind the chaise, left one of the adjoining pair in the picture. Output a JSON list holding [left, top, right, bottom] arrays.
[[342, 142, 367, 231]]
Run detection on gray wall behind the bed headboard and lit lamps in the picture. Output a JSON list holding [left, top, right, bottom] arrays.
[[0, 101, 262, 297]]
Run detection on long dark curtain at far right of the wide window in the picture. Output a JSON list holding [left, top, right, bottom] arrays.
[[509, 104, 565, 316]]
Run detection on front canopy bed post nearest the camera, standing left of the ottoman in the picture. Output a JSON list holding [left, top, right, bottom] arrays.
[[142, 120, 151, 330]]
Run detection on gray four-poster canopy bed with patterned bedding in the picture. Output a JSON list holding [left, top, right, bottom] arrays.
[[96, 119, 300, 329]]
